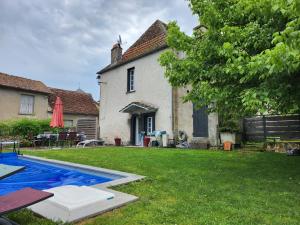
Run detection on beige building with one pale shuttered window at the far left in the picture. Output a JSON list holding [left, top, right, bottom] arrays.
[[0, 73, 51, 120]]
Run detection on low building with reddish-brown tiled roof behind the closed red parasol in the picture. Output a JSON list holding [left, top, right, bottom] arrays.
[[48, 88, 99, 139]]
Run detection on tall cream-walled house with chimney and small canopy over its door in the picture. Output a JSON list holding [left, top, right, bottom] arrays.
[[97, 20, 218, 145]]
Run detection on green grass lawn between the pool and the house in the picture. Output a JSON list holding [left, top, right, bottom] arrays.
[[5, 147, 300, 225]]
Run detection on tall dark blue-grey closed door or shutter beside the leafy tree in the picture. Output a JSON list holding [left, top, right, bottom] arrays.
[[193, 106, 208, 137]]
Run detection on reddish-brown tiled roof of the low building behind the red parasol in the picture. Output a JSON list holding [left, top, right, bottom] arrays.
[[48, 88, 99, 116]]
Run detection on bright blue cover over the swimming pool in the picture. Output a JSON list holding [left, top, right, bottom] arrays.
[[0, 153, 112, 195]]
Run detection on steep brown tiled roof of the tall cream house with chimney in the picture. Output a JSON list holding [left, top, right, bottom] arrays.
[[97, 20, 167, 74]]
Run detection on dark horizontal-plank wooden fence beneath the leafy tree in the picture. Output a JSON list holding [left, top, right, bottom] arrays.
[[244, 115, 300, 141]]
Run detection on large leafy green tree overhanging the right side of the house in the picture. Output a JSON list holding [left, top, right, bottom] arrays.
[[160, 0, 300, 116]]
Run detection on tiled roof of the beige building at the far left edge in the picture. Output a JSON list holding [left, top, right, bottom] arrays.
[[0, 72, 51, 94]]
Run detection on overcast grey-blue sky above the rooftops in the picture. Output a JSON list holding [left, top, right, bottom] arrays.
[[0, 0, 197, 100]]
